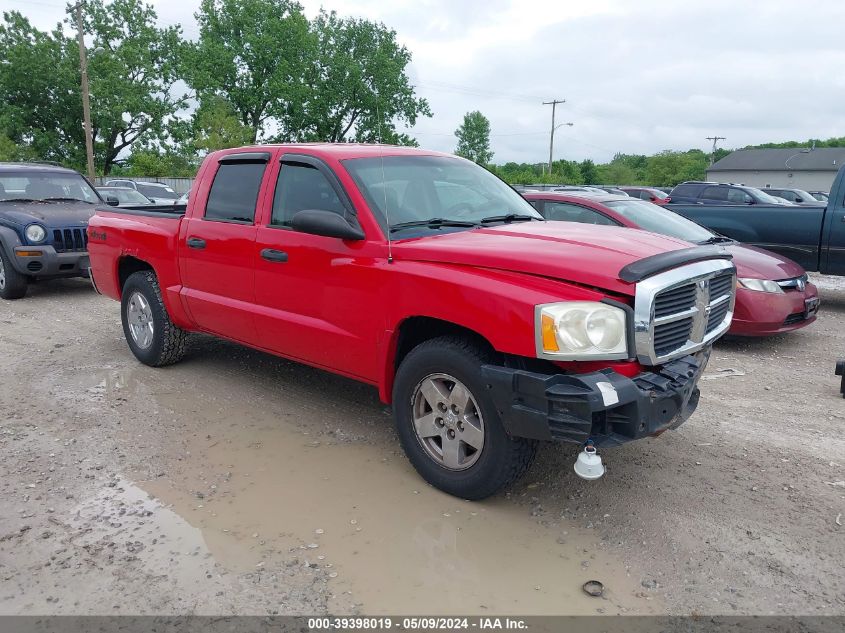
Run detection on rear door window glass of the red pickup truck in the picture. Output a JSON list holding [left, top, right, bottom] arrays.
[[205, 162, 266, 224]]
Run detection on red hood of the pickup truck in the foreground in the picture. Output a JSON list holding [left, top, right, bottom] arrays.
[[393, 222, 690, 295]]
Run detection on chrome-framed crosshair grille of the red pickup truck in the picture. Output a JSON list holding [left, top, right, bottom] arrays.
[[634, 260, 736, 365]]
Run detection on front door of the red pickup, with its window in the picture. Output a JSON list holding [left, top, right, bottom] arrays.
[[255, 154, 384, 382]]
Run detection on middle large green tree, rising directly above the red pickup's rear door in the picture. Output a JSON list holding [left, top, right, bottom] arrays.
[[185, 0, 316, 142]]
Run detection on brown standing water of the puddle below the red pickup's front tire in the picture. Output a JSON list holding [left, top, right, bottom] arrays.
[[140, 428, 642, 614]]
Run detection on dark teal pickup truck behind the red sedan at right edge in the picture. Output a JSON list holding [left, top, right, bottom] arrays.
[[668, 168, 845, 275]]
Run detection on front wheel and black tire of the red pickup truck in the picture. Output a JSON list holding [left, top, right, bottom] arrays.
[[393, 336, 538, 500]]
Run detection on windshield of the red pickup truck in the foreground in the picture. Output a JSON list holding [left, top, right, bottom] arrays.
[[344, 156, 543, 232]]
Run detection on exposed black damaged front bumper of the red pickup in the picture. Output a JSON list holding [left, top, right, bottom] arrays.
[[482, 350, 710, 447]]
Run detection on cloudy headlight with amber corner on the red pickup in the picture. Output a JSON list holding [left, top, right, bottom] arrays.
[[535, 301, 628, 360]]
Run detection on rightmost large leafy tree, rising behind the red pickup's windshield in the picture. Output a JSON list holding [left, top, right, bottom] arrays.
[[288, 11, 431, 145]]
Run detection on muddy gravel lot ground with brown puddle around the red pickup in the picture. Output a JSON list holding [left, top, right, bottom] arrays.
[[0, 278, 845, 614]]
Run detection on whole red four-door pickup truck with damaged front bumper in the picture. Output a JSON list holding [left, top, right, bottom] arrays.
[[88, 144, 736, 499]]
